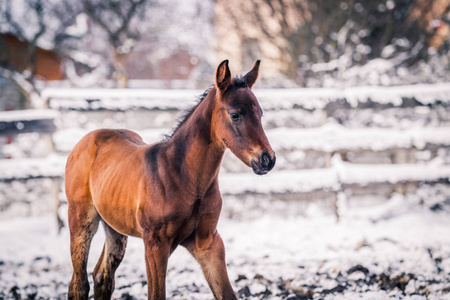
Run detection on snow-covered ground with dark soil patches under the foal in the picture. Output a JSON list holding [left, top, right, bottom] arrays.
[[0, 185, 450, 299]]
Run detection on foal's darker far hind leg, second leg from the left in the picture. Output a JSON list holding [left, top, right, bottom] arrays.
[[93, 222, 128, 299]]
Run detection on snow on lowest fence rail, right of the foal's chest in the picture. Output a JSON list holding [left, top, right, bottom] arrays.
[[219, 156, 450, 195]]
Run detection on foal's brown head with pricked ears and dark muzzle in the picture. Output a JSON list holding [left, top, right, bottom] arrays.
[[212, 60, 275, 175]]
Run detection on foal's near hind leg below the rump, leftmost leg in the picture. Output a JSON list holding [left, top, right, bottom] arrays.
[[68, 201, 100, 299]]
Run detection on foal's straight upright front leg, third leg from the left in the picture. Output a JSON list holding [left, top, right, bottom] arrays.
[[144, 234, 170, 300]]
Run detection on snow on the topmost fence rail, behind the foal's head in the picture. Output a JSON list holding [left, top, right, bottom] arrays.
[[42, 83, 450, 110]]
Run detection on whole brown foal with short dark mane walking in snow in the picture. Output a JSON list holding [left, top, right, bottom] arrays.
[[65, 60, 275, 299]]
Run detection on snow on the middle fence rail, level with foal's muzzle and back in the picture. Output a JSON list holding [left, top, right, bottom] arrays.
[[53, 124, 450, 153]]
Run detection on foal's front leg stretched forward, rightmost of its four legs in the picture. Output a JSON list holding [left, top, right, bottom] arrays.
[[184, 231, 237, 300]]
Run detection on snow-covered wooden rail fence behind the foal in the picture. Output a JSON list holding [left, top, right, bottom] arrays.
[[0, 84, 450, 226]]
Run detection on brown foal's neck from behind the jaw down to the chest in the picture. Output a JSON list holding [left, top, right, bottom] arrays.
[[170, 88, 225, 197]]
